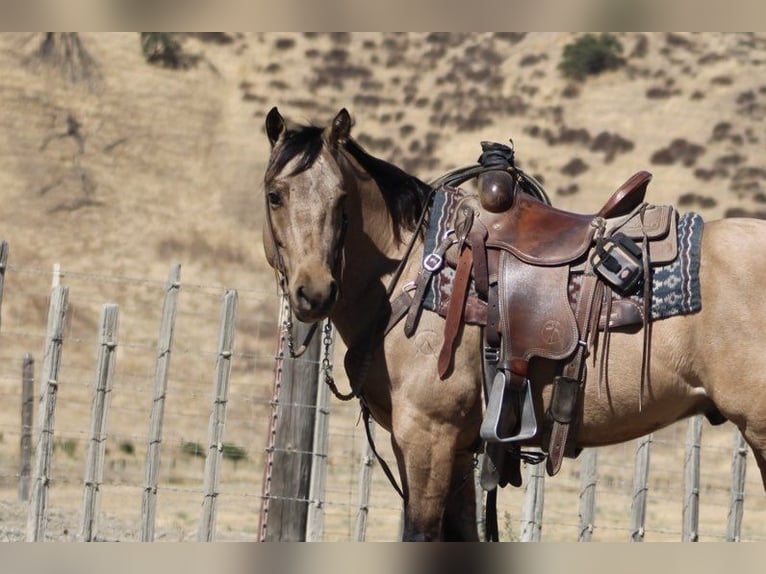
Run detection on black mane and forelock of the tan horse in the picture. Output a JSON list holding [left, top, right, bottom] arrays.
[[266, 122, 431, 240]]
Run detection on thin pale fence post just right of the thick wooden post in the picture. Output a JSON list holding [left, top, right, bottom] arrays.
[[306, 319, 334, 542]]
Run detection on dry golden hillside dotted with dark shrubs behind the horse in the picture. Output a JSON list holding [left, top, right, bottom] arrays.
[[0, 33, 766, 535]]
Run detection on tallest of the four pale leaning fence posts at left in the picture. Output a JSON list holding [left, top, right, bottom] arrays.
[[141, 264, 181, 542]]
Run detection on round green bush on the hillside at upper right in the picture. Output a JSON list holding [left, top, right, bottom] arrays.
[[559, 33, 625, 80]]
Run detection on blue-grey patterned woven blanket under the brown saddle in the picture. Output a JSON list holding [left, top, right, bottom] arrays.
[[423, 187, 704, 324]]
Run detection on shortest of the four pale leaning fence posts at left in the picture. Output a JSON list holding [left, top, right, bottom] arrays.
[[80, 303, 120, 542]]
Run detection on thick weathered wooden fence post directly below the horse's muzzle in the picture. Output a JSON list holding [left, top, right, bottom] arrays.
[[259, 307, 321, 542]]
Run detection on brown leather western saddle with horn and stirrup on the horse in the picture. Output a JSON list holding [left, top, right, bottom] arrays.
[[405, 142, 678, 490]]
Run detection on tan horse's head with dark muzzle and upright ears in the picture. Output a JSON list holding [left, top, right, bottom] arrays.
[[263, 107, 352, 323]]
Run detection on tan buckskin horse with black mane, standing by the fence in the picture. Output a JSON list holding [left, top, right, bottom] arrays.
[[263, 107, 766, 541]]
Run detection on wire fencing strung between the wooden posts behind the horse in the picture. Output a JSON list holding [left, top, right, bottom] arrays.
[[0, 258, 766, 541]]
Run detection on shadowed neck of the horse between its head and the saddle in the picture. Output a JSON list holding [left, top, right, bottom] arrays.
[[331, 164, 418, 346]]
